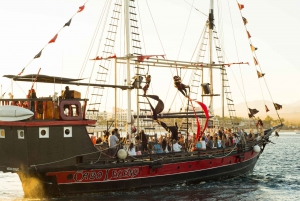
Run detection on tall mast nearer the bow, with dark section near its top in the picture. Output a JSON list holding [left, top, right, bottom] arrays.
[[208, 0, 214, 113]]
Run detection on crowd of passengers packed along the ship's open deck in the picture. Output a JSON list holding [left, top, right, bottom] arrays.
[[96, 127, 257, 156]]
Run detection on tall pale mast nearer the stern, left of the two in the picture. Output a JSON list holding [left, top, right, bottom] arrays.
[[124, 0, 132, 141]]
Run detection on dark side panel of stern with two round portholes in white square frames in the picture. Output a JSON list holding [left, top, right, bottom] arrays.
[[28, 126, 96, 167]]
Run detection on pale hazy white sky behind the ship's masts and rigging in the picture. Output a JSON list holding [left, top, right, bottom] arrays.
[[0, 0, 300, 116]]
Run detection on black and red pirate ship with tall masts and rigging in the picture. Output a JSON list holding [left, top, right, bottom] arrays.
[[0, 0, 282, 197]]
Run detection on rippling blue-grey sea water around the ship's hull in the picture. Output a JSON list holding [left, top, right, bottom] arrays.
[[0, 132, 300, 201]]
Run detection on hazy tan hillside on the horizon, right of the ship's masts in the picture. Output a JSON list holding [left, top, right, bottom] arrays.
[[215, 100, 300, 123]]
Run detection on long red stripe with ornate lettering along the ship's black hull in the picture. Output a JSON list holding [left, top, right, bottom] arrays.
[[46, 151, 258, 184]]
